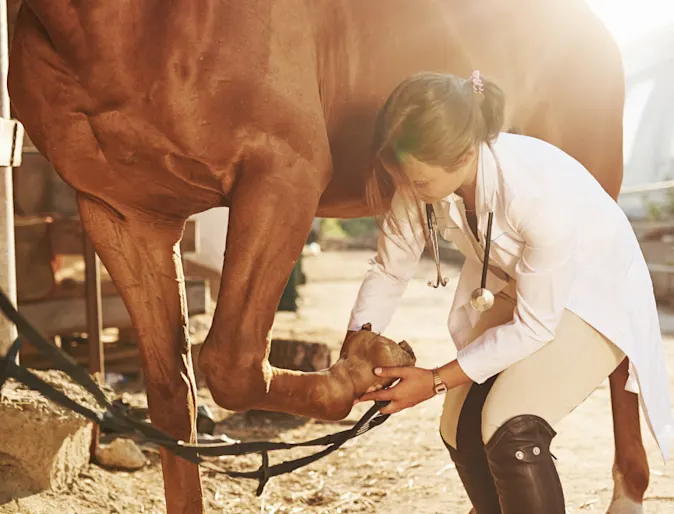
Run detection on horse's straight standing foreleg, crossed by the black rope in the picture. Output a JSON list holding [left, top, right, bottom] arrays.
[[78, 196, 203, 514]]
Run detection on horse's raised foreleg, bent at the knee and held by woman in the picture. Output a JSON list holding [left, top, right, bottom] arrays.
[[199, 135, 410, 419]]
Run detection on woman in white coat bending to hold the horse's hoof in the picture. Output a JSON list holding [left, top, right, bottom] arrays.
[[349, 72, 672, 514]]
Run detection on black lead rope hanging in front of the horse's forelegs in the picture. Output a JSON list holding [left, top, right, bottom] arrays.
[[0, 289, 390, 496]]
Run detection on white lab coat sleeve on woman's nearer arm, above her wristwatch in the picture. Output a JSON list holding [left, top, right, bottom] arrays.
[[457, 196, 577, 384]]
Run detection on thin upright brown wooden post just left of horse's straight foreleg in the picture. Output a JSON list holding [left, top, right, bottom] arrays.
[[82, 231, 105, 452]]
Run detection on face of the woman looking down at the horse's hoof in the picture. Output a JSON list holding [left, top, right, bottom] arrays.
[[401, 150, 477, 203]]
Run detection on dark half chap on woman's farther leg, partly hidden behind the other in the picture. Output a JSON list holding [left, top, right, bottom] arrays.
[[443, 377, 501, 514]]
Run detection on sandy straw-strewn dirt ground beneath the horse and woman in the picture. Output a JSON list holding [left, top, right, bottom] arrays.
[[0, 252, 674, 514]]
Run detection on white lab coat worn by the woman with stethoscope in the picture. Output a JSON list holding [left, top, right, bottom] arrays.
[[349, 133, 674, 460]]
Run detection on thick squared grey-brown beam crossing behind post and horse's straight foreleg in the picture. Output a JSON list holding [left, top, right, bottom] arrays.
[[19, 280, 210, 337]]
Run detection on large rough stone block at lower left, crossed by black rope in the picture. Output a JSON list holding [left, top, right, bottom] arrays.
[[0, 371, 95, 504]]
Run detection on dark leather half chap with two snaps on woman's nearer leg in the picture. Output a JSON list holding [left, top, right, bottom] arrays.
[[478, 414, 565, 514]]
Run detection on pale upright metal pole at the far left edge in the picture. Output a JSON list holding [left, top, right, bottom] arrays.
[[0, 0, 17, 356]]
